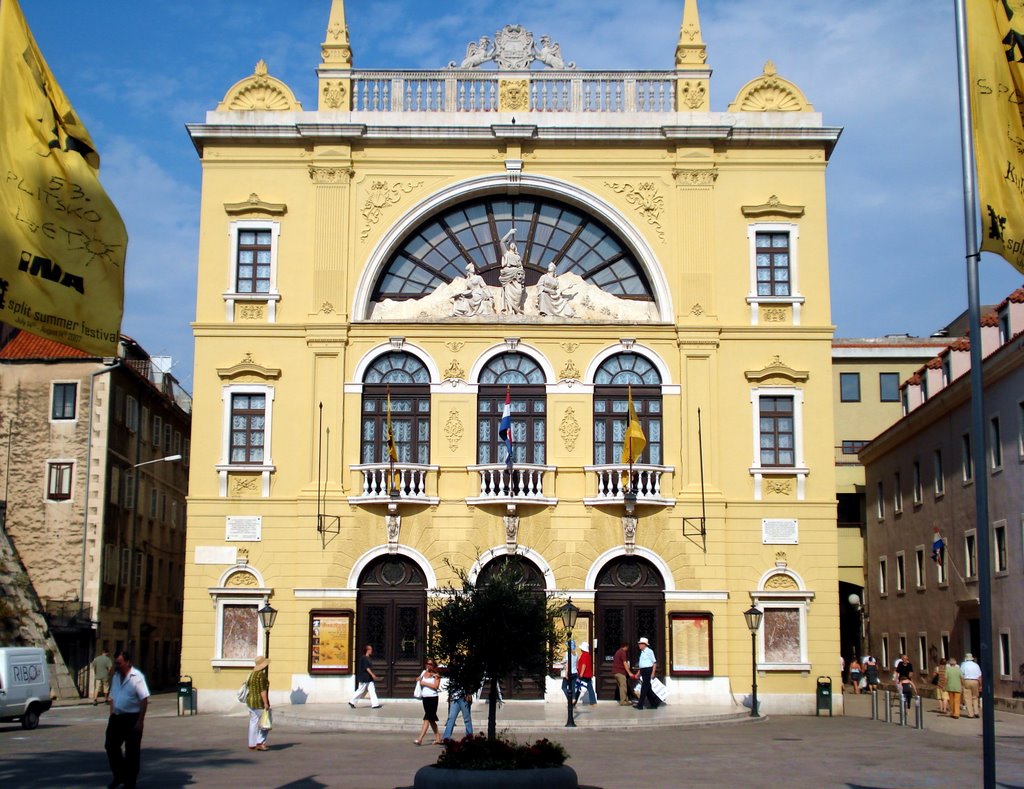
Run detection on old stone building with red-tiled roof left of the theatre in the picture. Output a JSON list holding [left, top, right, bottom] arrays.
[[0, 332, 190, 693]]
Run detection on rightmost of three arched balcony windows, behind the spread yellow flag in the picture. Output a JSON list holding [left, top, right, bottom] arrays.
[[594, 353, 663, 466]]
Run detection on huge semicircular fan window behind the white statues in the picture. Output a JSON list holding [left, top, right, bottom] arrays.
[[372, 195, 653, 303]]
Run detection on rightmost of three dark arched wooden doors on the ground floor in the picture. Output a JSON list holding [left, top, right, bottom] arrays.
[[594, 556, 667, 699]]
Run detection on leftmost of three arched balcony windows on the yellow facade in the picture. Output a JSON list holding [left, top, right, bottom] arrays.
[[359, 351, 430, 464]]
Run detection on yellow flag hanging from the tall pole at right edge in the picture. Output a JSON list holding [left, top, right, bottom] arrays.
[[966, 0, 1024, 272]]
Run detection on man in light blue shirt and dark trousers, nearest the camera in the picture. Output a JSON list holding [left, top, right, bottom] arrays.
[[104, 650, 150, 789]]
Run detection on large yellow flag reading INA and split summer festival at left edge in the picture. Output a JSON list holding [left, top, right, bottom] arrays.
[[0, 0, 128, 356]]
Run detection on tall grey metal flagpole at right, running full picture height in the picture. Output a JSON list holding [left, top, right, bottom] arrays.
[[953, 0, 995, 789]]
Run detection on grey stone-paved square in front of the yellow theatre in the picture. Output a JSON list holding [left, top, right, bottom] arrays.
[[9, 694, 1024, 789]]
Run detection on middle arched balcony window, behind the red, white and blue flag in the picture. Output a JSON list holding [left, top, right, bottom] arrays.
[[476, 353, 547, 466]]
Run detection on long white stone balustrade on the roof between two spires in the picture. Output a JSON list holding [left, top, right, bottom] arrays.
[[351, 69, 680, 113]]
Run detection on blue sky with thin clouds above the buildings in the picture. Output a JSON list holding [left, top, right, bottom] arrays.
[[20, 0, 1024, 389]]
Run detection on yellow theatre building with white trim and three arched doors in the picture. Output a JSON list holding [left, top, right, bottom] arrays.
[[182, 0, 842, 712]]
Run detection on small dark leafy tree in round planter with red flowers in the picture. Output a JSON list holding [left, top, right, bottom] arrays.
[[414, 557, 579, 789]]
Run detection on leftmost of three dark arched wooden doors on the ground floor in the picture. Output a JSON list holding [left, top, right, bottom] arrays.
[[355, 556, 427, 698]]
